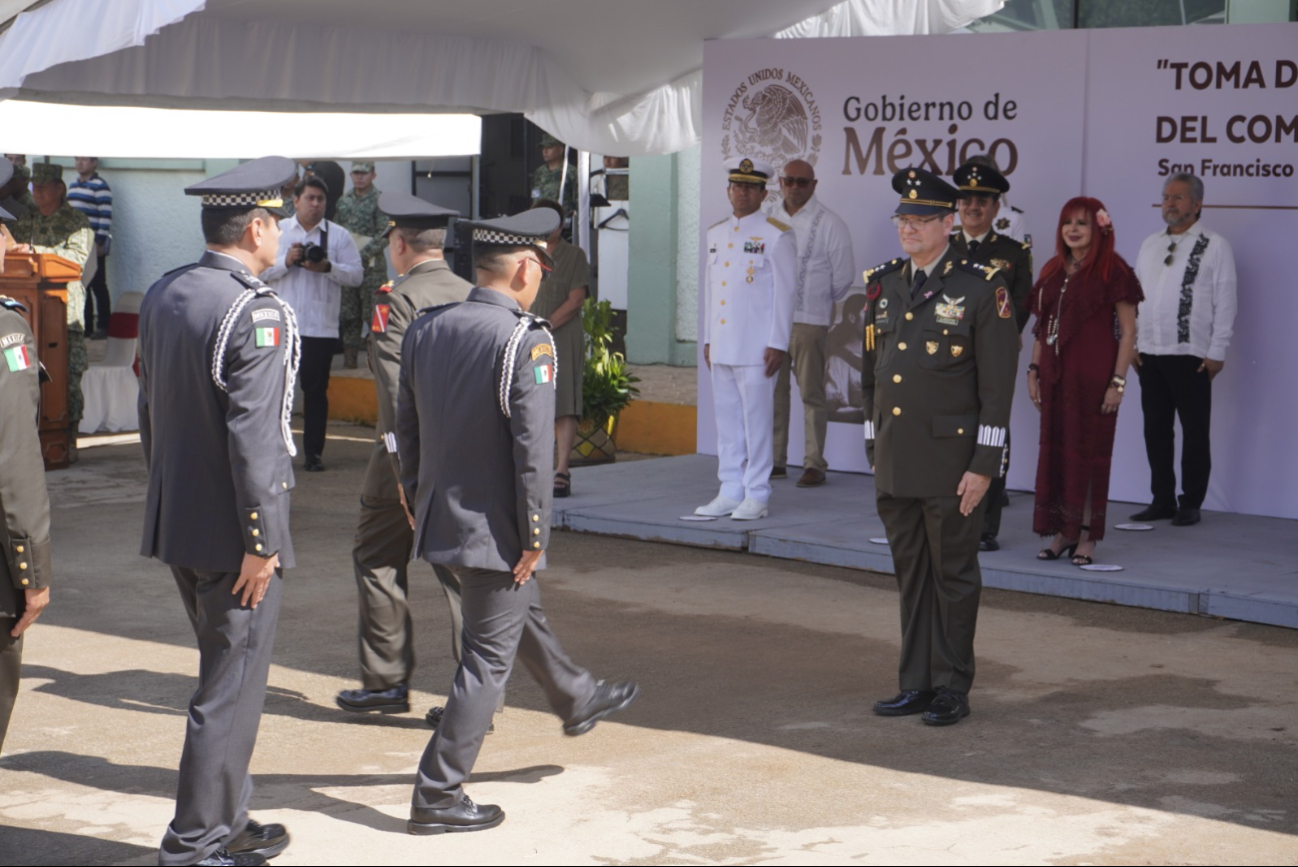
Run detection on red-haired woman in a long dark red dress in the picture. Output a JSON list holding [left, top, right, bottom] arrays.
[[1028, 196, 1145, 566]]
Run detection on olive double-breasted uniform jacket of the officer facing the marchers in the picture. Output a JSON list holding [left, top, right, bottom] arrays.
[[861, 248, 1019, 497]]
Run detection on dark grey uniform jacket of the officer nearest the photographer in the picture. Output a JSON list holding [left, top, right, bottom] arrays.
[[139, 250, 297, 572]]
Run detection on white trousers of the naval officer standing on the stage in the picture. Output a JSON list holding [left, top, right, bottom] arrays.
[[713, 363, 775, 502]]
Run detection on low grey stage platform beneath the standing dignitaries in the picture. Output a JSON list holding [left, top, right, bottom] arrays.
[[554, 454, 1298, 628]]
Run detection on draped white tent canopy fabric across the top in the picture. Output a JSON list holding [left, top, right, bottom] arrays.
[[0, 0, 1003, 156]]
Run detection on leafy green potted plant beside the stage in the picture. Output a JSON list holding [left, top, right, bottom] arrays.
[[570, 299, 640, 465]]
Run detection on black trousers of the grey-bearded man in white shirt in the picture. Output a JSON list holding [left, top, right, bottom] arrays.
[[1140, 353, 1212, 509]]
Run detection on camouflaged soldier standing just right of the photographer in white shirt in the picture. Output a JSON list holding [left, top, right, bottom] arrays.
[[337, 161, 388, 367]]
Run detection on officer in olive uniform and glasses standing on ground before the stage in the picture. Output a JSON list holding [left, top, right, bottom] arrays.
[[861, 169, 1018, 726]]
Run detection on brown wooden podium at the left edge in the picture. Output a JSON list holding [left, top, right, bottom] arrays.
[[0, 252, 80, 470]]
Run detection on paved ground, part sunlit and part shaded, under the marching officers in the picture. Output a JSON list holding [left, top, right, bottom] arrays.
[[0, 426, 1298, 864]]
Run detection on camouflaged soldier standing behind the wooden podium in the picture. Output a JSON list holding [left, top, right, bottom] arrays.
[[10, 162, 95, 461]]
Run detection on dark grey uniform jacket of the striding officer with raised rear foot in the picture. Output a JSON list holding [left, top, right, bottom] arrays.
[[397, 287, 556, 570]]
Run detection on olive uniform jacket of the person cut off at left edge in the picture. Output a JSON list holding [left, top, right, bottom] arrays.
[[0, 296, 51, 597]]
